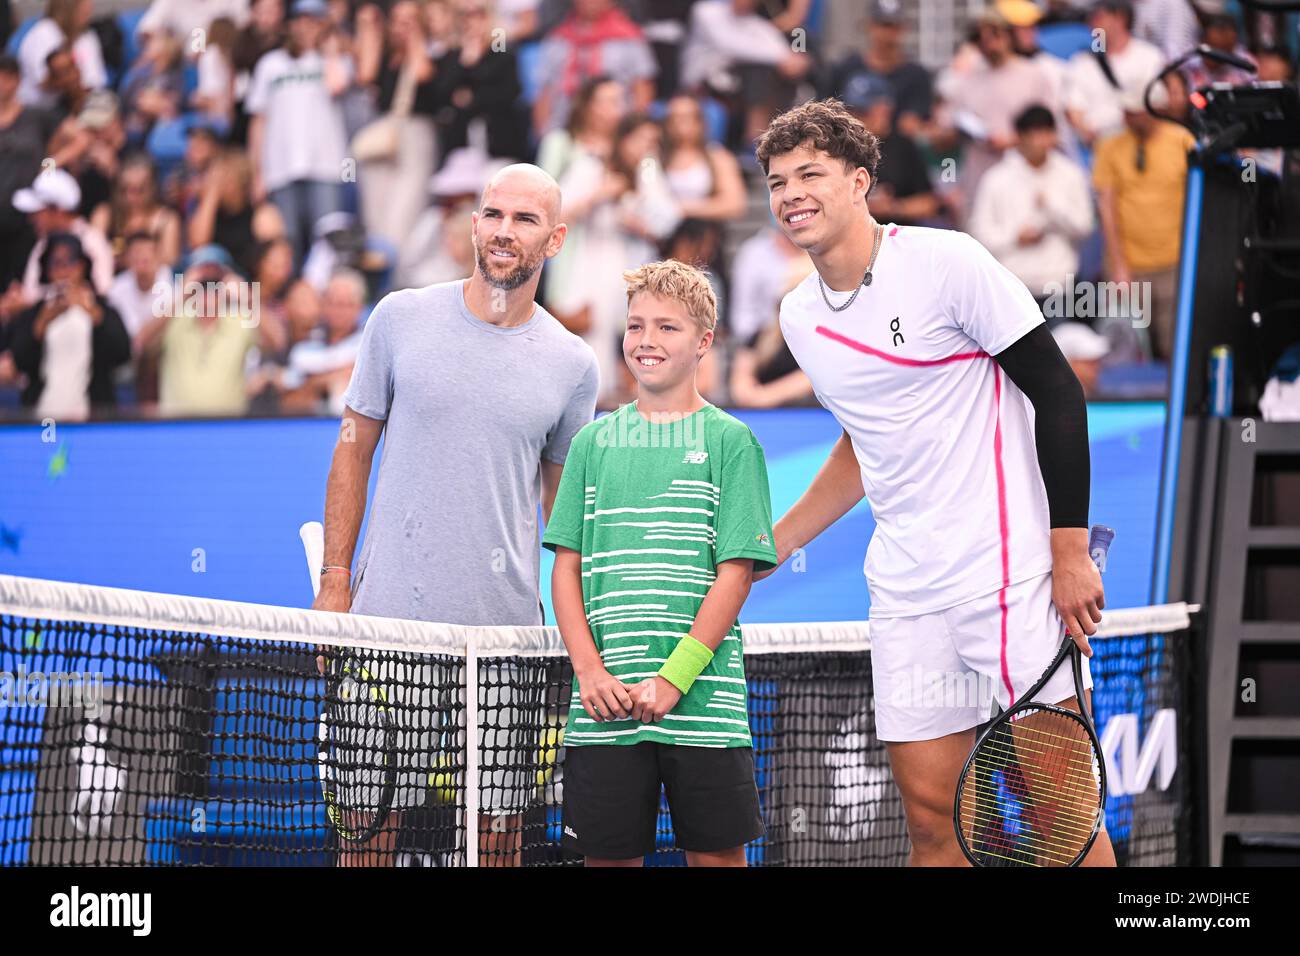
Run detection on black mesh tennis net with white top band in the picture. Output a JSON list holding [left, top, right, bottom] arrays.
[[0, 575, 1196, 866]]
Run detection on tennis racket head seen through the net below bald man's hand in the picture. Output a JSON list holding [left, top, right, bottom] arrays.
[[317, 652, 398, 843]]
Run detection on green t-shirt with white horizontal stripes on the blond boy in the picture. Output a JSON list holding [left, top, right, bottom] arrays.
[[542, 405, 776, 747]]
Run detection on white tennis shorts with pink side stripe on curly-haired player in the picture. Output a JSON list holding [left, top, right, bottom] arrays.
[[871, 574, 1092, 741]]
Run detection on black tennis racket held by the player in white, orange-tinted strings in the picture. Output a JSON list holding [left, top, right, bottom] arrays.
[[953, 524, 1115, 866]]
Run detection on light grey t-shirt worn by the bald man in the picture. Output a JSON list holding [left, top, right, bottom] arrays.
[[343, 280, 599, 624]]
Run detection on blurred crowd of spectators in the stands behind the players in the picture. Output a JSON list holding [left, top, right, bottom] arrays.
[[0, 0, 1296, 418]]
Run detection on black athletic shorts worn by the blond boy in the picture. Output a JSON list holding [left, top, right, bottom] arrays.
[[563, 743, 766, 860]]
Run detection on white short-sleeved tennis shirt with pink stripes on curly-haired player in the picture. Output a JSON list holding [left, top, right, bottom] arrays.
[[781, 225, 1052, 618]]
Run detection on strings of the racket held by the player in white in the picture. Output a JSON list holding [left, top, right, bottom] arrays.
[[958, 710, 1101, 866]]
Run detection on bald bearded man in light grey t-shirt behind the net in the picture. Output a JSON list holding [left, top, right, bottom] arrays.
[[313, 164, 599, 866]]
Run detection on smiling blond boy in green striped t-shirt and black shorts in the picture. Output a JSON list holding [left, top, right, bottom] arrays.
[[543, 261, 776, 866]]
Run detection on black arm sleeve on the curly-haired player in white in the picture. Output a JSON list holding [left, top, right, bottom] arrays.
[[995, 325, 1091, 528]]
